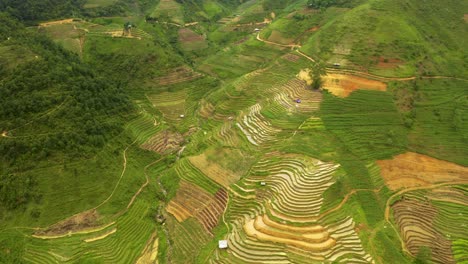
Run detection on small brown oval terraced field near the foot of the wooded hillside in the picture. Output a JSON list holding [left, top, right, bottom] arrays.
[[140, 130, 184, 154]]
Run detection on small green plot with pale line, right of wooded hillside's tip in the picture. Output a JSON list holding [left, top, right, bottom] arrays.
[[147, 90, 187, 120]]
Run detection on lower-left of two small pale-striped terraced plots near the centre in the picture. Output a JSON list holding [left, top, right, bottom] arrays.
[[237, 104, 280, 146]]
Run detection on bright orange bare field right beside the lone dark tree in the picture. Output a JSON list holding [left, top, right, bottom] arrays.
[[323, 73, 387, 97]]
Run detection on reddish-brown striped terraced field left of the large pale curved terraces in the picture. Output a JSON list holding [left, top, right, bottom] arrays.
[[166, 180, 228, 232]]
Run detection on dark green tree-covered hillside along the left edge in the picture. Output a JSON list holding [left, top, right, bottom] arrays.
[[0, 13, 131, 209]]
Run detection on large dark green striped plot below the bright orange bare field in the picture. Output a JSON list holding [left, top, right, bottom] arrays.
[[320, 90, 407, 160]]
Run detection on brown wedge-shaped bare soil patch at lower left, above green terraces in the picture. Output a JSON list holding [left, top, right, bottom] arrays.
[[34, 210, 99, 236]]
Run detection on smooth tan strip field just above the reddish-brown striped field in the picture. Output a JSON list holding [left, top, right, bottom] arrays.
[[189, 154, 240, 188]]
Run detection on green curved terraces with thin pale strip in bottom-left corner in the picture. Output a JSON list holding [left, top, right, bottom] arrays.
[[24, 200, 155, 263]]
